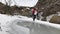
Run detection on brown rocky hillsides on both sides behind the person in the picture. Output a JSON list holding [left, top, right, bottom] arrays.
[[0, 0, 60, 23]]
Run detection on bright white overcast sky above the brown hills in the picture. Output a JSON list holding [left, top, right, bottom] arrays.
[[0, 0, 38, 7]]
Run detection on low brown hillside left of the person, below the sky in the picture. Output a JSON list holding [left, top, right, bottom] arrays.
[[0, 2, 30, 16]]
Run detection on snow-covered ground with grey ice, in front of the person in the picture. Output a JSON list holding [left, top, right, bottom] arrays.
[[0, 14, 60, 34]]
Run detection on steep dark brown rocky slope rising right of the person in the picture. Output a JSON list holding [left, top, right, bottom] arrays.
[[35, 0, 60, 17]]
